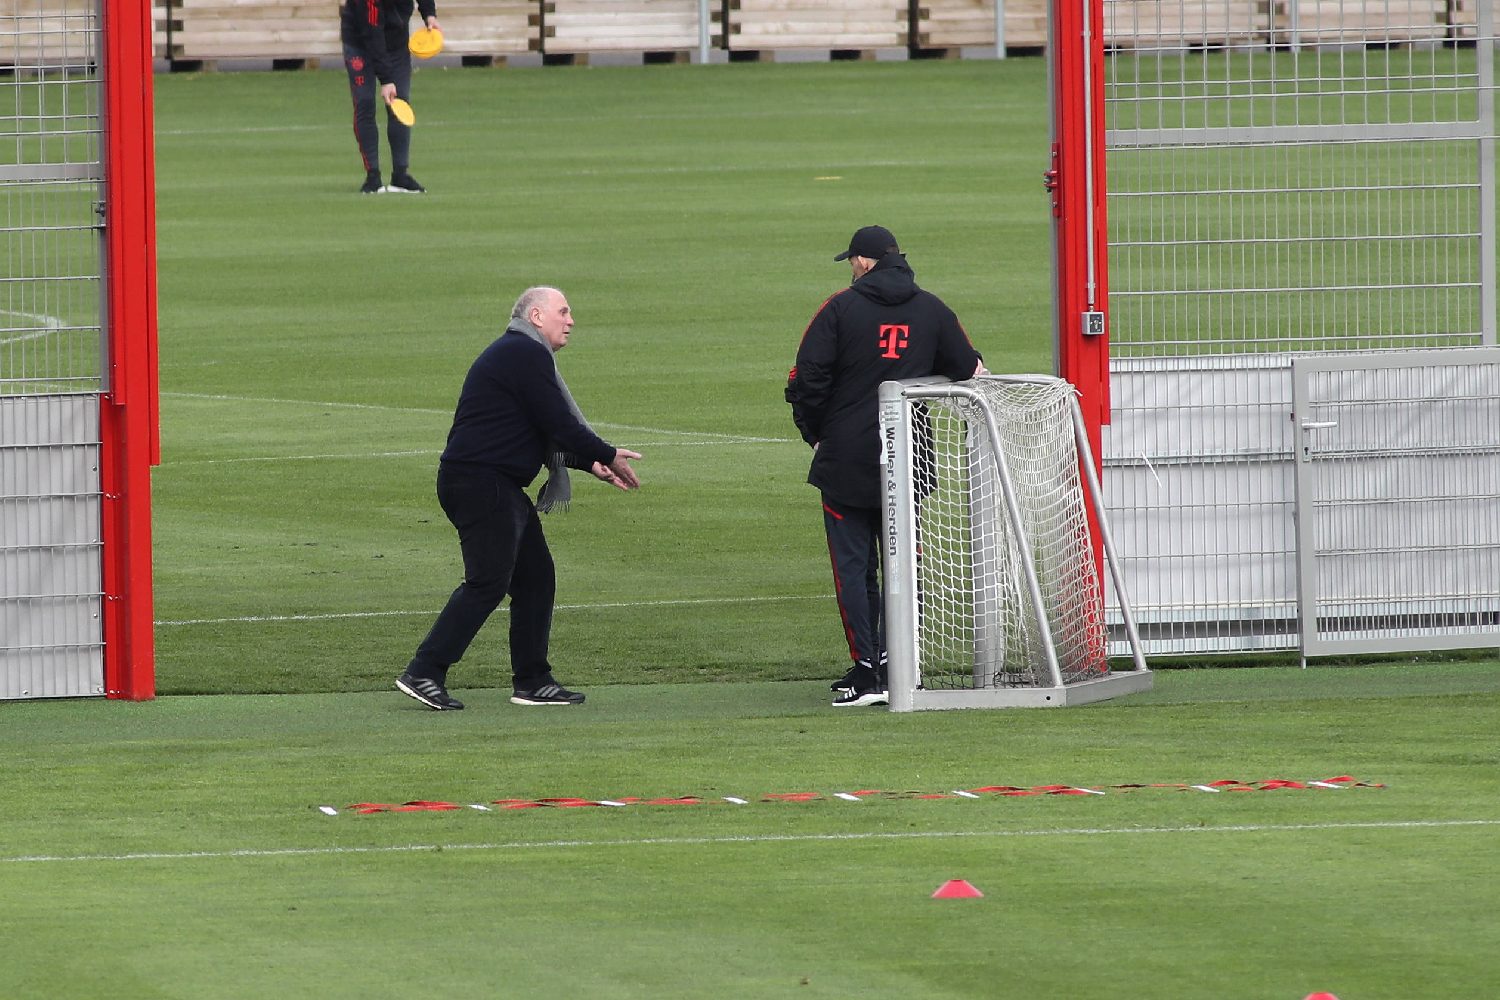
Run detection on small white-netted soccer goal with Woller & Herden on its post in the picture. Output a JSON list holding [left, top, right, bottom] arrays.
[[881, 375, 1151, 712]]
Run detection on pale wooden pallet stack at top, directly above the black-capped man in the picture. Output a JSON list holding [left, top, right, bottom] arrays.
[[725, 0, 911, 54]]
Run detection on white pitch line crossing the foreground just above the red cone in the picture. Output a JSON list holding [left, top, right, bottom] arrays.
[[0, 820, 1500, 865]]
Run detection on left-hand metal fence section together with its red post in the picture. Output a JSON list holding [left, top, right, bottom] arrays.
[[0, 0, 161, 699]]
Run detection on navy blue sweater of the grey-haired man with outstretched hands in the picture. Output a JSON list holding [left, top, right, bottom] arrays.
[[443, 330, 615, 486]]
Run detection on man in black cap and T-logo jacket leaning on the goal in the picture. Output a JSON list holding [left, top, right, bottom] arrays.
[[786, 226, 984, 706]]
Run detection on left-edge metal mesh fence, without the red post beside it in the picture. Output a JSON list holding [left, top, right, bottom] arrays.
[[0, 0, 107, 699]]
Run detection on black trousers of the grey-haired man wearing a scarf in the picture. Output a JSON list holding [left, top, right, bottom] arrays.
[[407, 469, 557, 688]]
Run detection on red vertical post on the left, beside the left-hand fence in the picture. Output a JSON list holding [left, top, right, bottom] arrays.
[[99, 0, 161, 700]]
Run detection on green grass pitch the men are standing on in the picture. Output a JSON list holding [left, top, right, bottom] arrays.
[[0, 60, 1500, 1000]]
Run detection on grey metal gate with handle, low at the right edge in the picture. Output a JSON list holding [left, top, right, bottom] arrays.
[[1296, 349, 1500, 652]]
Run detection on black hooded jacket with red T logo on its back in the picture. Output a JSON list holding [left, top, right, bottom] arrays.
[[786, 253, 980, 508]]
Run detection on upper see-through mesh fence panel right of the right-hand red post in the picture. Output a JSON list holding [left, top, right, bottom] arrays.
[[1104, 28, 1494, 357]]
